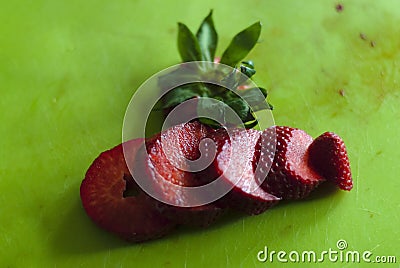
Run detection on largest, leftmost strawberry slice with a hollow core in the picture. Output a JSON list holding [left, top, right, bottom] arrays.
[[80, 139, 175, 242]]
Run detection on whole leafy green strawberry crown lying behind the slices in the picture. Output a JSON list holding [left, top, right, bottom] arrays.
[[167, 16, 272, 128]]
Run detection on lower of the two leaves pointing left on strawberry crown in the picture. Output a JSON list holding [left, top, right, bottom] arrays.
[[155, 84, 201, 109]]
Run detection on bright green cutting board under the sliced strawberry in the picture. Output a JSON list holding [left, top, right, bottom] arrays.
[[0, 0, 400, 267]]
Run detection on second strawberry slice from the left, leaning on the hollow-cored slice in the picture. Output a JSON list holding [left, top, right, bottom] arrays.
[[142, 121, 223, 226]]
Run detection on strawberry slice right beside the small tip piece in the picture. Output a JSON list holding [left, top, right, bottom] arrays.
[[259, 126, 324, 200]]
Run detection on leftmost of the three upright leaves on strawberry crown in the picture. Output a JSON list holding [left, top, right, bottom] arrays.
[[178, 22, 203, 62]]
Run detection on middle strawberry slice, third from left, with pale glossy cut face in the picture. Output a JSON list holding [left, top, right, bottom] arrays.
[[210, 129, 279, 215]]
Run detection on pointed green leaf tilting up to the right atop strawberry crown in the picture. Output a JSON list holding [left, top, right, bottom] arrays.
[[221, 22, 261, 67]]
